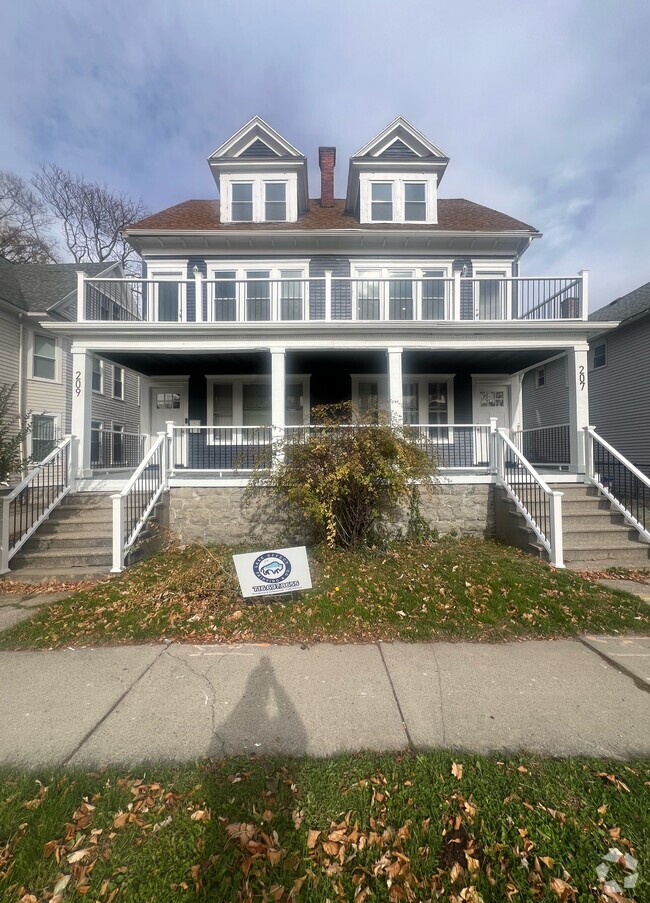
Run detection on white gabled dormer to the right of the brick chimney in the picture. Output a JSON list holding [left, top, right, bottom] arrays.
[[345, 116, 449, 223]]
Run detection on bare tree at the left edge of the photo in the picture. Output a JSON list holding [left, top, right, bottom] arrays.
[[0, 170, 58, 263]]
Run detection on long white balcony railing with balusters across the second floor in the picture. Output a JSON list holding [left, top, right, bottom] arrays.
[[77, 270, 588, 326]]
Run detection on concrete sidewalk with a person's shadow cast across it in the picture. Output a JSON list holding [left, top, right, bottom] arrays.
[[0, 637, 650, 766]]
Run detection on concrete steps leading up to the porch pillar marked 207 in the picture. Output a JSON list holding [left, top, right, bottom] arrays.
[[550, 483, 650, 571]]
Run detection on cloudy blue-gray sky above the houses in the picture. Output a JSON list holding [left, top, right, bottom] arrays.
[[0, 0, 650, 309]]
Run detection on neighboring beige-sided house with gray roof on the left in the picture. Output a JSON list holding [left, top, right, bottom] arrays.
[[0, 258, 140, 469]]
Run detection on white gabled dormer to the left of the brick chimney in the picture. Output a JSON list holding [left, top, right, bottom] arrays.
[[208, 116, 309, 223]]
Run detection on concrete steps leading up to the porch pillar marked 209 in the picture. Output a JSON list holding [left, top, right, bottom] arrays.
[[7, 492, 113, 582]]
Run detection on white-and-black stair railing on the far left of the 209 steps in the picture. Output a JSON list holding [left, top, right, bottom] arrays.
[[0, 436, 74, 574]]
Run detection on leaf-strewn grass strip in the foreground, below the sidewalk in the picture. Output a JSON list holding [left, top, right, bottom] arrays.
[[0, 752, 650, 903]]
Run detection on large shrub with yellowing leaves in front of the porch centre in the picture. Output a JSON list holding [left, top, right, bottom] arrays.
[[247, 402, 437, 548]]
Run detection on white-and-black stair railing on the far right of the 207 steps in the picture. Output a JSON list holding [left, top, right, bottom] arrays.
[[584, 426, 650, 542]]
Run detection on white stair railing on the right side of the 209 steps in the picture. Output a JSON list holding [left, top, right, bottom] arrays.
[[111, 433, 167, 574]]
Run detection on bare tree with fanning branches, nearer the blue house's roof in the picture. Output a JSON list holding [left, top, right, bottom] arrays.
[[32, 164, 148, 270]]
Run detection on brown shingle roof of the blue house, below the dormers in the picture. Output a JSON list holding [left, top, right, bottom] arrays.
[[126, 198, 537, 232]]
